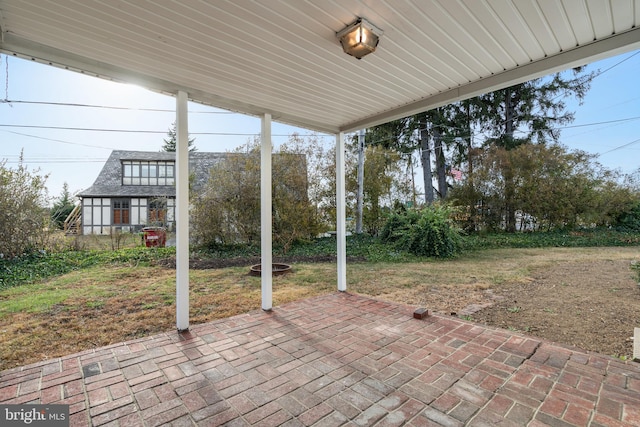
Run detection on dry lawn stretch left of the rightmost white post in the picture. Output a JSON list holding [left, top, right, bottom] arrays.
[[0, 264, 335, 370]]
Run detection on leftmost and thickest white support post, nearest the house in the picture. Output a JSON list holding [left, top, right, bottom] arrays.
[[176, 91, 189, 331]]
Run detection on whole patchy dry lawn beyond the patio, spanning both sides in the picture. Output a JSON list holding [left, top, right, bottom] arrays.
[[0, 247, 640, 370]]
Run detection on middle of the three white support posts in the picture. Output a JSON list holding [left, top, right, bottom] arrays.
[[260, 114, 273, 311]]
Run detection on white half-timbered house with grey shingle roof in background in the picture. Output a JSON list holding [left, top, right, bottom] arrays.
[[73, 150, 229, 234]]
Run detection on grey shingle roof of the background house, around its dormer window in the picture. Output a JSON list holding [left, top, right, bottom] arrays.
[[78, 150, 232, 197]]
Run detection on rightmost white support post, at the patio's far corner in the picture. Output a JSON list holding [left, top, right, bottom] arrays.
[[336, 132, 347, 292]]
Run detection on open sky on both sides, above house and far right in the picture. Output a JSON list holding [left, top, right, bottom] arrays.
[[0, 51, 640, 204]]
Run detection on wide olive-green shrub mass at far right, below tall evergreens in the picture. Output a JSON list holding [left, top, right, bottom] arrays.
[[448, 144, 638, 232]]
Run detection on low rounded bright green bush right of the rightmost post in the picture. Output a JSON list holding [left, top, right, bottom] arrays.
[[380, 205, 461, 258]]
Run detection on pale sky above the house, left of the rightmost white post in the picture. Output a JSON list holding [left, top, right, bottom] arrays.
[[0, 54, 335, 203]]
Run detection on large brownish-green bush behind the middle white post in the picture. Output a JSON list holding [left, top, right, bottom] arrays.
[[191, 142, 320, 252]]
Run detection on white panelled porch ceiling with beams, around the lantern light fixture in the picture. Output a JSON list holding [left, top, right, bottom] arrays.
[[0, 0, 640, 133]]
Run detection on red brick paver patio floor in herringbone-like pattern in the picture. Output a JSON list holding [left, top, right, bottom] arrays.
[[0, 293, 640, 427]]
